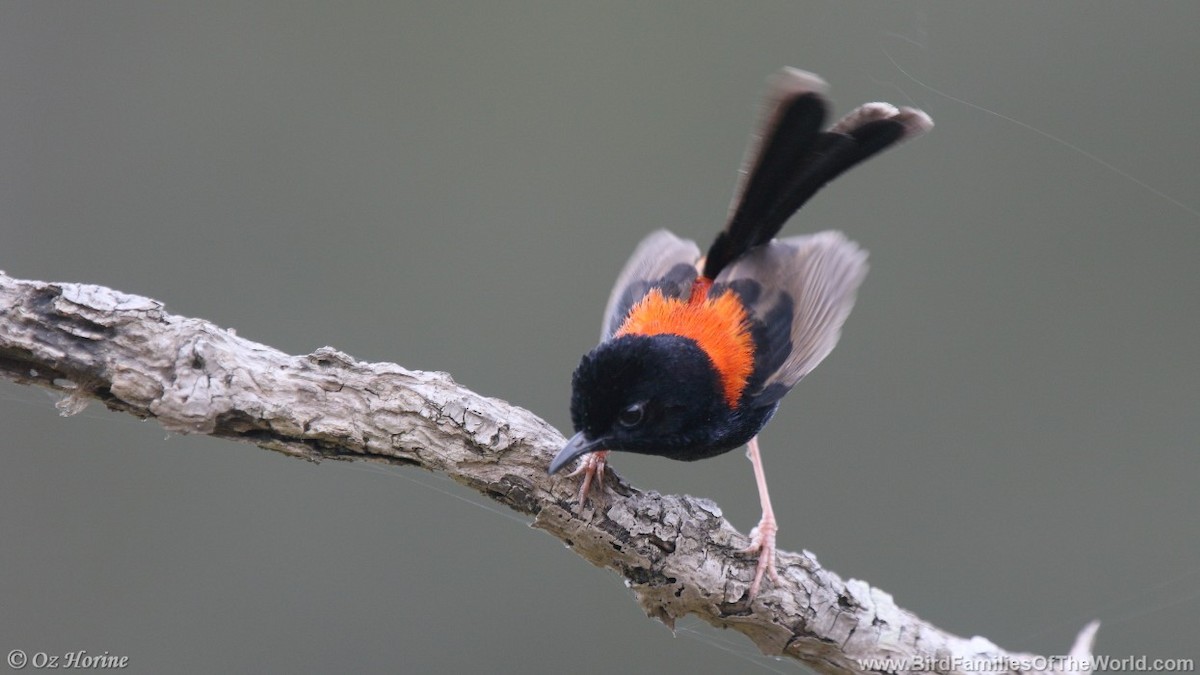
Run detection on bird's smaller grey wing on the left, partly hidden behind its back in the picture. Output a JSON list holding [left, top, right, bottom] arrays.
[[600, 229, 700, 342]]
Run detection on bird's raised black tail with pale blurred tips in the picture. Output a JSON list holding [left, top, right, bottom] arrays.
[[703, 68, 934, 279]]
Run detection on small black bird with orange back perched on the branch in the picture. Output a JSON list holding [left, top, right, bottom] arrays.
[[550, 68, 932, 599]]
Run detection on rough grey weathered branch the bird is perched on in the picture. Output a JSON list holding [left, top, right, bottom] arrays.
[[0, 273, 1098, 673]]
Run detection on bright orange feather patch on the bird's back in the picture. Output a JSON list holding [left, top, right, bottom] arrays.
[[614, 280, 754, 407]]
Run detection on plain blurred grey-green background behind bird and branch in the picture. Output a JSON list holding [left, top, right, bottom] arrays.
[[0, 1, 1200, 673]]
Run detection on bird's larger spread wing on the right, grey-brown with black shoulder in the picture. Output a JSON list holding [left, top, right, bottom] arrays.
[[709, 231, 866, 407]]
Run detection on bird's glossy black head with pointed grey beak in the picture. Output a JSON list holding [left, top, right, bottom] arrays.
[[550, 335, 729, 473]]
